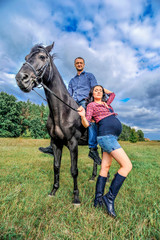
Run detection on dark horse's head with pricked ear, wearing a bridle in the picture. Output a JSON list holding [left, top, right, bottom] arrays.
[[16, 43, 54, 92]]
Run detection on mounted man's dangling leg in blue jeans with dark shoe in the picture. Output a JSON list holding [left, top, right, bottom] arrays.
[[88, 122, 101, 165]]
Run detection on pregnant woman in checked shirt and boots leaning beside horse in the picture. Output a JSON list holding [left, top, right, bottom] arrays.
[[78, 85, 132, 217]]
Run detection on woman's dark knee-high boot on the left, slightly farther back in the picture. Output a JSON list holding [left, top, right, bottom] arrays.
[[94, 175, 107, 207]]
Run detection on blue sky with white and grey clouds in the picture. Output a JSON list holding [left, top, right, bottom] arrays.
[[0, 0, 160, 139]]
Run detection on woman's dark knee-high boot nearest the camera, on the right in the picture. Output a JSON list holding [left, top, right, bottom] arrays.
[[102, 173, 126, 218]]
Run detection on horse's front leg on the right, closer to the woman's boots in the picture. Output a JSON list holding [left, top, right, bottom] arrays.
[[68, 138, 81, 205]]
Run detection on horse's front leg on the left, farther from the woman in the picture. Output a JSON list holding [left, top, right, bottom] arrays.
[[49, 140, 63, 196]]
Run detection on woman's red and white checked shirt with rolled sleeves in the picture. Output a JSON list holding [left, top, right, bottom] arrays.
[[86, 92, 117, 123]]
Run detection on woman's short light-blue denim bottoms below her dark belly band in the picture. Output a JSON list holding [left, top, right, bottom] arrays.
[[97, 134, 121, 153]]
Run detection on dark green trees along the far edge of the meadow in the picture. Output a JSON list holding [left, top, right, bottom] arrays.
[[0, 92, 144, 142]]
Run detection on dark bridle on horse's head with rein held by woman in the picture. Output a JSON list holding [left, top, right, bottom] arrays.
[[23, 47, 78, 112]]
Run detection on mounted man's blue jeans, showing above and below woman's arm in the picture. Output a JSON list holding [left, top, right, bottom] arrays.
[[77, 99, 97, 149]]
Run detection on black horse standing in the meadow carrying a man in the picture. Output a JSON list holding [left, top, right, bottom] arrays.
[[16, 43, 97, 204]]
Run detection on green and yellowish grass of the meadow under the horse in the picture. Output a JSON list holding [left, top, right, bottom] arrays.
[[0, 138, 160, 240]]
